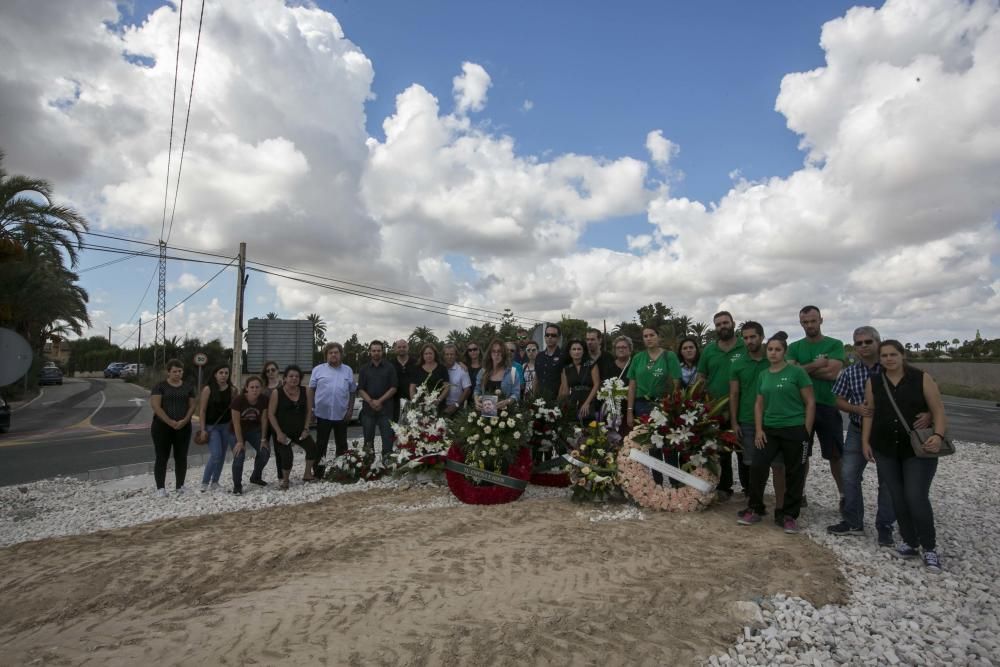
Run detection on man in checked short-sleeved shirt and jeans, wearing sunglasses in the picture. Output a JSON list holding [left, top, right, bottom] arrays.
[[826, 326, 896, 547]]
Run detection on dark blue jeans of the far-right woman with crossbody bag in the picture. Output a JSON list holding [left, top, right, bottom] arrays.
[[875, 451, 937, 551]]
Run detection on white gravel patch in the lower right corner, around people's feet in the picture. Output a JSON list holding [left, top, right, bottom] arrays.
[[707, 442, 1000, 665]]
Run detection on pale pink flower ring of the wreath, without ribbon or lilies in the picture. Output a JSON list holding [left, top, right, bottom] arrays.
[[618, 424, 719, 512]]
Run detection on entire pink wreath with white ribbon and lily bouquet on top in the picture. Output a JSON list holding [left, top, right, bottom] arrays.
[[617, 382, 735, 512]]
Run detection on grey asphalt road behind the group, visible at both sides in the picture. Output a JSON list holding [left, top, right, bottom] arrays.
[[0, 379, 1000, 486]]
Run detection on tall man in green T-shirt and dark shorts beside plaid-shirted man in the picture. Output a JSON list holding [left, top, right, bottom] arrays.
[[786, 306, 845, 503]]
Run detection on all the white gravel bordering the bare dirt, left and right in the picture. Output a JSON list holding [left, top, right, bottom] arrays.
[[0, 442, 1000, 666]]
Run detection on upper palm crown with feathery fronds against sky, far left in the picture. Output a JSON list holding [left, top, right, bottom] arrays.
[[0, 151, 87, 267]]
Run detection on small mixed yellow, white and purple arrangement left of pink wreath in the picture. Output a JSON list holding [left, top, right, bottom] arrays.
[[568, 421, 621, 502]]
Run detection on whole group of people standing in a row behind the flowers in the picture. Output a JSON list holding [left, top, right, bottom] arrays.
[[150, 306, 947, 571]]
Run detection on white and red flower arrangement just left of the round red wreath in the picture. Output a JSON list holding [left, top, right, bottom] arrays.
[[392, 382, 451, 473]]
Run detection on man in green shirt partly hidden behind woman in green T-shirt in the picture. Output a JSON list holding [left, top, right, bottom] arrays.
[[729, 322, 785, 525]]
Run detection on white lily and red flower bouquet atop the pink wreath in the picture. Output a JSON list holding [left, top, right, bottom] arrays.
[[634, 382, 736, 477]]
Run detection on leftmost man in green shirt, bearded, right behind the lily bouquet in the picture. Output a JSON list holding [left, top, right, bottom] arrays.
[[698, 310, 750, 500]]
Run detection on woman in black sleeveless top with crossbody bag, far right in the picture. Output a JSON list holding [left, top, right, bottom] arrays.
[[861, 340, 948, 572]]
